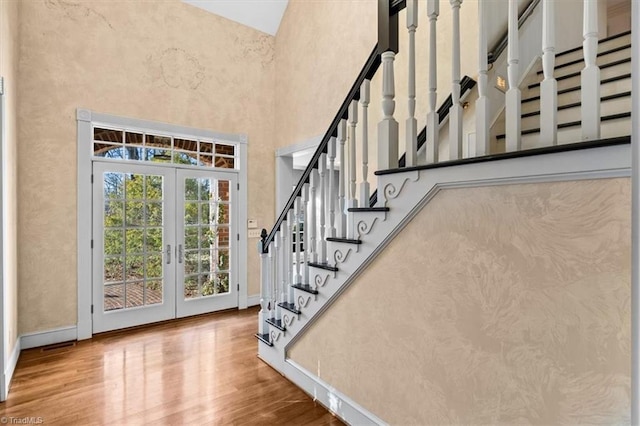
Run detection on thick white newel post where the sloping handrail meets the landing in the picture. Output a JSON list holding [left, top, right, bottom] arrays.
[[378, 51, 398, 173]]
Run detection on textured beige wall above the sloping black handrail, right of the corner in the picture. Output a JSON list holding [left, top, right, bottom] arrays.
[[275, 0, 378, 147]]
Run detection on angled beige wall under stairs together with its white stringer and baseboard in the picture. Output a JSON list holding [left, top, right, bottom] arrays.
[[259, 138, 630, 424]]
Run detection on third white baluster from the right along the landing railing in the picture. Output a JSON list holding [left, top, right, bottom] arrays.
[[505, 0, 522, 152]]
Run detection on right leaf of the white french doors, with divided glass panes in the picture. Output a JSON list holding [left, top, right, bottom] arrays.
[[177, 170, 237, 316]]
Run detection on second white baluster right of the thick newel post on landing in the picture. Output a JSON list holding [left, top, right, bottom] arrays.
[[425, 0, 440, 163]]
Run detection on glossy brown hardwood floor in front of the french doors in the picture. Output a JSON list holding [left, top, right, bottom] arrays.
[[0, 308, 342, 425]]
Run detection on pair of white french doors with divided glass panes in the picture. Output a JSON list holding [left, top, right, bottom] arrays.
[[93, 161, 238, 333]]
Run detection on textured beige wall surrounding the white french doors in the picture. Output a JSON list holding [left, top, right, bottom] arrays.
[[18, 0, 275, 333]]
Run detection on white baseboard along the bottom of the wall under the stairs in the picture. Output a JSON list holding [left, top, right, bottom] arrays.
[[285, 359, 387, 425]]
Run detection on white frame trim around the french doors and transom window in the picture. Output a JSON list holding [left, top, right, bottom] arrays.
[[76, 108, 248, 340]]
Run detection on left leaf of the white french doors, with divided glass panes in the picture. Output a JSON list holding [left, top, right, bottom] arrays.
[[94, 163, 175, 331]]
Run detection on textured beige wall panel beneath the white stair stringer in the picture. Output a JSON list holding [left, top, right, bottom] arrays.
[[289, 179, 631, 425]]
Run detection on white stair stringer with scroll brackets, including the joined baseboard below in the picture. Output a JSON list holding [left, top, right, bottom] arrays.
[[258, 144, 631, 424]]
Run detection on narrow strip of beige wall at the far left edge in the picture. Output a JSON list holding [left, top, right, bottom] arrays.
[[0, 0, 19, 366]]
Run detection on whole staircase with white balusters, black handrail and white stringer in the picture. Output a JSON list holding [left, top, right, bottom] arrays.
[[256, 0, 632, 424]]
